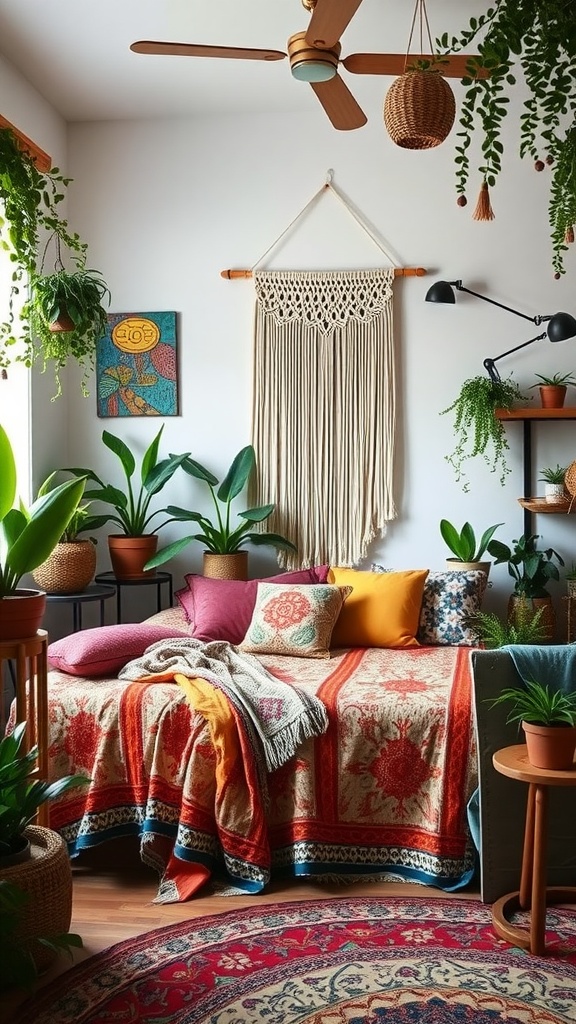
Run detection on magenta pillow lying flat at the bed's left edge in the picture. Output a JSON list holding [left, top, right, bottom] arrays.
[[48, 623, 190, 676]]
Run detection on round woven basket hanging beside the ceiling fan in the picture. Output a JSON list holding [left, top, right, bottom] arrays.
[[384, 70, 456, 150]]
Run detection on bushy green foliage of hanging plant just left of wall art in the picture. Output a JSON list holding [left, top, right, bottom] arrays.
[[24, 266, 111, 398]]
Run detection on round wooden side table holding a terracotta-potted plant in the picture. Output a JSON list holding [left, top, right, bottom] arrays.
[[492, 743, 576, 956]]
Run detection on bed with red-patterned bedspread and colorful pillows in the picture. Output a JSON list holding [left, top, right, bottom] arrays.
[[39, 566, 486, 901]]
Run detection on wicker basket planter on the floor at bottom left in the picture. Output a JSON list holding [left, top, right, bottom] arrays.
[[0, 825, 72, 971]]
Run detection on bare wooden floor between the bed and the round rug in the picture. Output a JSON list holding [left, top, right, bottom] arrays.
[[0, 840, 480, 1024]]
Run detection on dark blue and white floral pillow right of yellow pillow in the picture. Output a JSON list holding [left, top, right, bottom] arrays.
[[371, 563, 488, 647]]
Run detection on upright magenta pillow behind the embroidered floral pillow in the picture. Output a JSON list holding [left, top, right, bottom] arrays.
[[175, 565, 329, 644]]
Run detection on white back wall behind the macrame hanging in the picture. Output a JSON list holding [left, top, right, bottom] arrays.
[[4, 56, 576, 634]]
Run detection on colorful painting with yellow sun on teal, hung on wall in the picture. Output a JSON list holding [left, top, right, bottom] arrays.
[[96, 312, 178, 417]]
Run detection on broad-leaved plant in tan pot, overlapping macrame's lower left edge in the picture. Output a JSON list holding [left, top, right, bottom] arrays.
[[144, 444, 296, 580]]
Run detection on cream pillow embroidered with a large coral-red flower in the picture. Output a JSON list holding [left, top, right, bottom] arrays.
[[240, 583, 352, 657]]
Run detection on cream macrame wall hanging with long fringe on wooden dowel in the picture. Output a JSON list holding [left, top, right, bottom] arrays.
[[222, 167, 425, 568]]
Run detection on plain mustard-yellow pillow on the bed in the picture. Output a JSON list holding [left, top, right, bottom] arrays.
[[328, 567, 428, 647]]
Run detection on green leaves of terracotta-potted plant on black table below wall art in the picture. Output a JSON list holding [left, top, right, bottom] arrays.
[[67, 426, 190, 537]]
